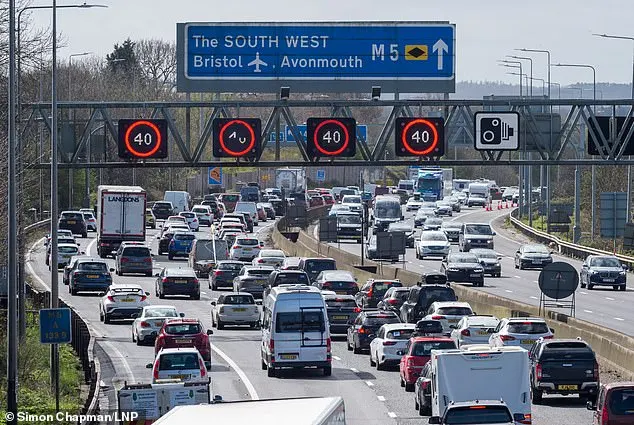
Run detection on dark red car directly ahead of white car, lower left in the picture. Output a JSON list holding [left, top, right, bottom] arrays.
[[154, 318, 213, 367]]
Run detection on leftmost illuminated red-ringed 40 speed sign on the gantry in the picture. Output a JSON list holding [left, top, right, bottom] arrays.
[[118, 119, 167, 159]]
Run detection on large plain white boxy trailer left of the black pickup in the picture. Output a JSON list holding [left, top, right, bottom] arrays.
[[431, 345, 531, 424]]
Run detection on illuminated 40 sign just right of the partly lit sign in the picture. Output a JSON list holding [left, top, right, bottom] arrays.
[[306, 118, 357, 158]]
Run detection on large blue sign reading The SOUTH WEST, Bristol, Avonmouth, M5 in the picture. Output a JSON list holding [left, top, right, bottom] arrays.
[[177, 22, 456, 93]]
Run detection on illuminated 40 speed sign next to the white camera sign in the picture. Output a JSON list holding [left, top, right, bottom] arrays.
[[395, 118, 445, 157]]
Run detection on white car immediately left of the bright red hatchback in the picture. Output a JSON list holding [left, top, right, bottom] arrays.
[[370, 323, 416, 370]]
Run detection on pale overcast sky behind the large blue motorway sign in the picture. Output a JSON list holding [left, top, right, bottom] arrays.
[[32, 0, 634, 84]]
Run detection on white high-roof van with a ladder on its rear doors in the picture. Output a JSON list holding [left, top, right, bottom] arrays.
[[260, 285, 332, 377]]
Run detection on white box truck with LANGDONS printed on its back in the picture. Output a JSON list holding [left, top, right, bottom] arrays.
[[97, 186, 147, 258]]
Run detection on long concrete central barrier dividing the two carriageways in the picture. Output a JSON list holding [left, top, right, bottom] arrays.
[[272, 210, 634, 380]]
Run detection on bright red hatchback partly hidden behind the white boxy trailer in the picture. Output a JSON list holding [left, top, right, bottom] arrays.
[[399, 336, 456, 392]]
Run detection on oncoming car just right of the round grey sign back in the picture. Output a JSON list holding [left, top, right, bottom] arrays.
[[579, 255, 627, 291]]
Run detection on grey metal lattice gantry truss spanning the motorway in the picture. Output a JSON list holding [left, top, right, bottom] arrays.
[[21, 98, 634, 168]]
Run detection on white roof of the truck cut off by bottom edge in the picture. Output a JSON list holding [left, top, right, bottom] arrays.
[[154, 397, 346, 425]]
